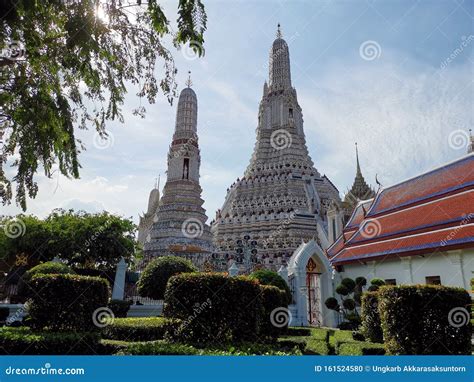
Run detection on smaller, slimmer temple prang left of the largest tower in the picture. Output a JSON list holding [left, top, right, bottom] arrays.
[[144, 79, 213, 268]]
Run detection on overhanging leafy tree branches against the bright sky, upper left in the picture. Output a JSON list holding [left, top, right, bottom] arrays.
[[0, 0, 207, 210]]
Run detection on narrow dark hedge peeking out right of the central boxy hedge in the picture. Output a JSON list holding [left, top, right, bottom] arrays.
[[260, 285, 289, 339]]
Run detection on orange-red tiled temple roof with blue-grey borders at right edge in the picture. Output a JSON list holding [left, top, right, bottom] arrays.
[[327, 154, 474, 265]]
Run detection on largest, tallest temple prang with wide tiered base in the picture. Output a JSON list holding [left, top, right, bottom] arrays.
[[211, 26, 340, 270]]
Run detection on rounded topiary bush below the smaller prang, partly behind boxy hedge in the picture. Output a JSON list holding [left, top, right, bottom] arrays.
[[137, 256, 197, 300]]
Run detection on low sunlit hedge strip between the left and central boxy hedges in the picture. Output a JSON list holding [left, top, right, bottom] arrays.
[[102, 317, 177, 341]]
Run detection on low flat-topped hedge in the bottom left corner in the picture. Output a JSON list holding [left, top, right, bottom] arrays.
[[0, 327, 99, 355]]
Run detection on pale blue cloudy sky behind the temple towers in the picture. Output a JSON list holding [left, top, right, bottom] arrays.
[[0, 0, 474, 222]]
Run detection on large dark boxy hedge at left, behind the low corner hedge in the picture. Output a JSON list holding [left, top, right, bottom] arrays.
[[28, 274, 109, 331]]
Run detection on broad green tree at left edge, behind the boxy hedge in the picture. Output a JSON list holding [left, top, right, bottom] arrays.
[[0, 210, 137, 270]]
